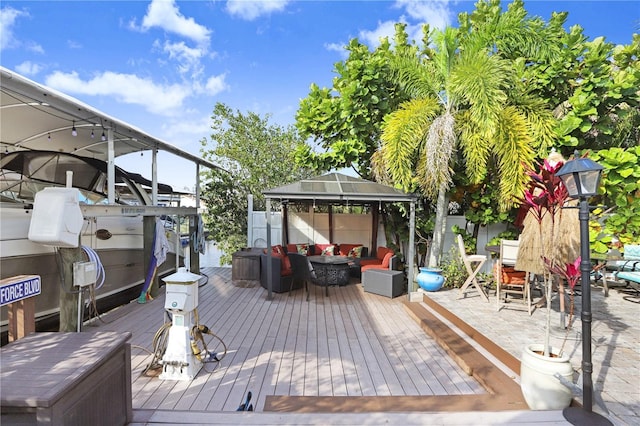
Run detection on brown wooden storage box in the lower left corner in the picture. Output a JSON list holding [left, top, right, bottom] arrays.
[[0, 332, 132, 426]]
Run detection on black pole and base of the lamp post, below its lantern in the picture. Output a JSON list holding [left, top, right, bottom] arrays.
[[563, 197, 612, 425]]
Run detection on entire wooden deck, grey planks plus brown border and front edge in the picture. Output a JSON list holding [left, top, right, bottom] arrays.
[[84, 268, 580, 425]]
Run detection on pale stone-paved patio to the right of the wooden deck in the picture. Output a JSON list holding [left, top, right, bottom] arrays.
[[420, 280, 640, 425]]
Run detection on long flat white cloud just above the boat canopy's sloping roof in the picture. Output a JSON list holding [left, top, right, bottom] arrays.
[[45, 71, 192, 115]]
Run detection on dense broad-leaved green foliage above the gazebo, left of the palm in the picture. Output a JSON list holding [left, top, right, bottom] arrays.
[[296, 34, 406, 178]]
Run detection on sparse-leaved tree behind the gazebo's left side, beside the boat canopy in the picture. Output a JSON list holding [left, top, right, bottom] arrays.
[[201, 103, 309, 264]]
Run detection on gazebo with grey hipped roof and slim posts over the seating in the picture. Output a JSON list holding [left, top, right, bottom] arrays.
[[262, 173, 417, 300]]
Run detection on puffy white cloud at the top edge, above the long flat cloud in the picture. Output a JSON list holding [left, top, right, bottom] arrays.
[[135, 0, 211, 46]]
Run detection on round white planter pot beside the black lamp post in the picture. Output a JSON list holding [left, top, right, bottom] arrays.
[[520, 344, 573, 410]]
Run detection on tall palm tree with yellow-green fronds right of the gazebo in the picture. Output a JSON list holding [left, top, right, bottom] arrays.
[[376, 1, 554, 267]]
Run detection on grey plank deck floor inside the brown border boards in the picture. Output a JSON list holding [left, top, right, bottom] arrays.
[[85, 268, 486, 411]]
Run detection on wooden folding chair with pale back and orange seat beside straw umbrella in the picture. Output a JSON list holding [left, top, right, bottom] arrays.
[[496, 240, 532, 315]]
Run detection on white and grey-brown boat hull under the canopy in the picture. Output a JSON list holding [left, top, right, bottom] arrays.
[[0, 206, 176, 338]]
